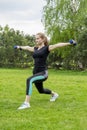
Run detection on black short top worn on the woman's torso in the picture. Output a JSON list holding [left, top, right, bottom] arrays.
[[33, 46, 49, 74]]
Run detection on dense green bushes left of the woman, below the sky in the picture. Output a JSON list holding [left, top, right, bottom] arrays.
[[0, 25, 34, 67]]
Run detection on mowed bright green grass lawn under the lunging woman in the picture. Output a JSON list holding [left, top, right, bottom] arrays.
[[0, 69, 87, 130]]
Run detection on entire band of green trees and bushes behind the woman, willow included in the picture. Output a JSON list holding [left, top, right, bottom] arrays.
[[0, 0, 87, 70]]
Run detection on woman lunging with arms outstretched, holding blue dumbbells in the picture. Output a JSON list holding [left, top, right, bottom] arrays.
[[14, 33, 76, 110]]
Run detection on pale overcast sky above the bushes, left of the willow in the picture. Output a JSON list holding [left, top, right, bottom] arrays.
[[0, 0, 46, 35]]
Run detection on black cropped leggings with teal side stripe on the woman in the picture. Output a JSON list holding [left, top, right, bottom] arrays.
[[26, 70, 51, 96]]
